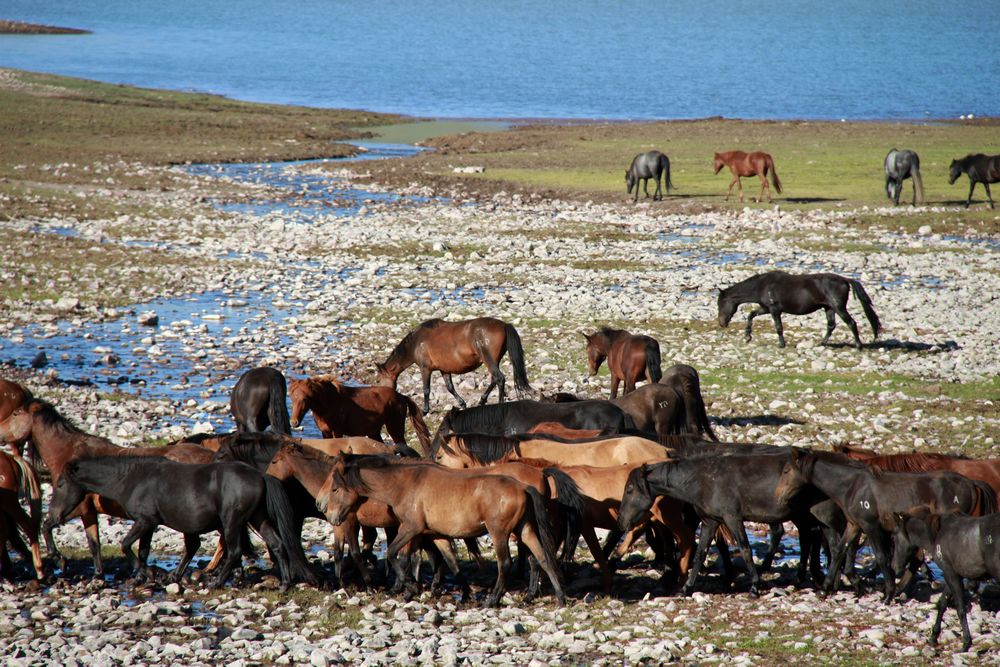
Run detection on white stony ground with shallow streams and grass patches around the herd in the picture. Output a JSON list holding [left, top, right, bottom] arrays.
[[0, 155, 1000, 665]]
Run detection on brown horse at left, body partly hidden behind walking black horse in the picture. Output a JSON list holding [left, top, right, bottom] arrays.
[[0, 398, 213, 576]]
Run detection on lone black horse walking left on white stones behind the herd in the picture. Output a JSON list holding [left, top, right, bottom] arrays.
[[718, 271, 882, 350]]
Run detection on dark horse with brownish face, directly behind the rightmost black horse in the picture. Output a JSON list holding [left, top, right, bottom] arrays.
[[774, 450, 997, 603]]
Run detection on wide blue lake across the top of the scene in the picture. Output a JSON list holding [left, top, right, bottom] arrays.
[[0, 0, 1000, 119]]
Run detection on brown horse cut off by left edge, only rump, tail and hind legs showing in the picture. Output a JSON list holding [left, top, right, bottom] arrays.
[[0, 452, 45, 580]]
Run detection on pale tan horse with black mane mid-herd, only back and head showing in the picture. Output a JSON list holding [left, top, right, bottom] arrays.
[[428, 433, 670, 468]]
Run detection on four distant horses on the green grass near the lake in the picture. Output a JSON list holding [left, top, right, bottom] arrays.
[[625, 148, 1000, 208]]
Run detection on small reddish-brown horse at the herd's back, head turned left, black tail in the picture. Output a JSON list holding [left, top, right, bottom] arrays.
[[583, 327, 663, 398]]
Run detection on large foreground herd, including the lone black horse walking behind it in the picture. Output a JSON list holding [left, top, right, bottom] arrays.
[[0, 272, 1000, 649]]
